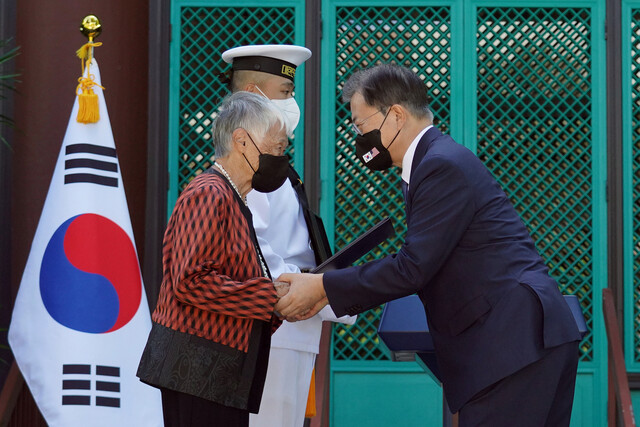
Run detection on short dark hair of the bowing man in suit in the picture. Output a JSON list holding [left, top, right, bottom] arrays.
[[342, 64, 433, 120]]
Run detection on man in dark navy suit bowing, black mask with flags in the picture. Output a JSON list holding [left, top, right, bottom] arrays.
[[276, 64, 580, 427]]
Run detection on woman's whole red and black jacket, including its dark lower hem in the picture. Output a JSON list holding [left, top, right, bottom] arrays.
[[137, 171, 280, 412]]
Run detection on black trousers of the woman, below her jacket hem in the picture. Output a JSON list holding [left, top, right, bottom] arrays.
[[160, 388, 249, 427]]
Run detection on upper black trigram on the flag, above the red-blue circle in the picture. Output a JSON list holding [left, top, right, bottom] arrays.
[[64, 144, 118, 187]]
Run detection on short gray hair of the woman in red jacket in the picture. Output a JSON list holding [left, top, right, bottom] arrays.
[[212, 91, 284, 158]]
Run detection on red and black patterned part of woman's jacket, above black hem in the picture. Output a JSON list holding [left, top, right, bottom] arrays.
[[152, 173, 279, 351]]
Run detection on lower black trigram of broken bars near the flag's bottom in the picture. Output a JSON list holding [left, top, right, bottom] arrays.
[[62, 365, 120, 408]]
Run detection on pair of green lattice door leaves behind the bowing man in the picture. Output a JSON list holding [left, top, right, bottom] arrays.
[[321, 0, 607, 427]]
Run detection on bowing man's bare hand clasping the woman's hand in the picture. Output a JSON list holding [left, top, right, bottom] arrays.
[[275, 273, 328, 322]]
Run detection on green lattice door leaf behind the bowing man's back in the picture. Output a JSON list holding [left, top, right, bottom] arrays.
[[466, 1, 607, 426]]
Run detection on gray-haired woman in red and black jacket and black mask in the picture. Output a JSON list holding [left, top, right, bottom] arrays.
[[137, 92, 288, 427]]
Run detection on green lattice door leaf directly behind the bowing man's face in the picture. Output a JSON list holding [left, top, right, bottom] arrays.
[[321, 0, 463, 427]]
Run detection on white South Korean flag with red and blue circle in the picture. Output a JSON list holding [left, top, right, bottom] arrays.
[[9, 60, 163, 427]]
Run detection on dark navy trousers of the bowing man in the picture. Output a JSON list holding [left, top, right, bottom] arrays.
[[459, 341, 579, 427]]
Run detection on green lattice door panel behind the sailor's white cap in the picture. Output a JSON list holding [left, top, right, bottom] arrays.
[[167, 0, 304, 215]]
